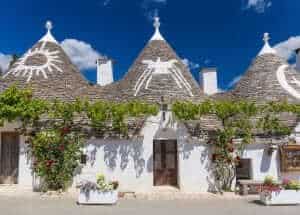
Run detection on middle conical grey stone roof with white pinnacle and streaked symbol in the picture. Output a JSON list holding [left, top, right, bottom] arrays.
[[97, 18, 205, 101]]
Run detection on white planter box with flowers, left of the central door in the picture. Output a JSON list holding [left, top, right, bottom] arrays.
[[78, 174, 119, 205]]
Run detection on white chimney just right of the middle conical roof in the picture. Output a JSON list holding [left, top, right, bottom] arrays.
[[200, 68, 218, 95]]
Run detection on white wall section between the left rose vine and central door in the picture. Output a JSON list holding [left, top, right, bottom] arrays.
[[76, 114, 161, 192]]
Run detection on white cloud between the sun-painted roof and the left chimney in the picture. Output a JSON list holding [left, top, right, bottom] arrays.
[[61, 39, 102, 70]]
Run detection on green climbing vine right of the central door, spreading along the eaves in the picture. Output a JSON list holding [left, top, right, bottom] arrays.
[[172, 100, 300, 192]]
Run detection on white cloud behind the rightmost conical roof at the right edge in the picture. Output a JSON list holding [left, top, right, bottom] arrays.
[[274, 36, 300, 60]]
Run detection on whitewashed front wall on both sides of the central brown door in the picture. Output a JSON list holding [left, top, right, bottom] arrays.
[[76, 114, 213, 193]]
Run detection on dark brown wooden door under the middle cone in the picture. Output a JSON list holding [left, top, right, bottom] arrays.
[[153, 140, 178, 186]]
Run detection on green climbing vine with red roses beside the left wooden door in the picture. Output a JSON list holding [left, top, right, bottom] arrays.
[[0, 86, 158, 190]]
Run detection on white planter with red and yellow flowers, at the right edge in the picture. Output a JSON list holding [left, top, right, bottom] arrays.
[[260, 177, 300, 205]]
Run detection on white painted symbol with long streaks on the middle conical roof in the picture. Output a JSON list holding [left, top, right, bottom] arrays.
[[134, 58, 193, 96]]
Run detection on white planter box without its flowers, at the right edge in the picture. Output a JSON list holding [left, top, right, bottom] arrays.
[[260, 190, 300, 205]]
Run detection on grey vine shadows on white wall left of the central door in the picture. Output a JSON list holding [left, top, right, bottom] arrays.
[[99, 139, 148, 178]]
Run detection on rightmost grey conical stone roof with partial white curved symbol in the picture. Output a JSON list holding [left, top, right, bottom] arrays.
[[232, 35, 300, 103]]
